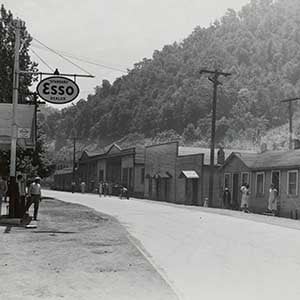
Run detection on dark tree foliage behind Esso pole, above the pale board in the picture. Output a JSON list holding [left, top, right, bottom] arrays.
[[0, 4, 37, 103]]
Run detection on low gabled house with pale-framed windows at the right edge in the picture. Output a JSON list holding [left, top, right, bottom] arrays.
[[220, 150, 300, 218]]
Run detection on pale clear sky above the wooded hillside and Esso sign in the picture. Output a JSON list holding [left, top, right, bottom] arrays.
[[0, 0, 250, 108]]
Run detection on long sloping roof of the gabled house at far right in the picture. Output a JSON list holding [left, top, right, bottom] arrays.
[[234, 150, 300, 169]]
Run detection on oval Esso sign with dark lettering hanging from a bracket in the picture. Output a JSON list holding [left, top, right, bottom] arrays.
[[36, 76, 79, 104]]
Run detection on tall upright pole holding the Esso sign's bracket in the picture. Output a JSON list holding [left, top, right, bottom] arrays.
[[9, 20, 22, 217]]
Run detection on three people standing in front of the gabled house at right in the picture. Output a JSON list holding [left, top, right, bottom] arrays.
[[223, 183, 278, 215]]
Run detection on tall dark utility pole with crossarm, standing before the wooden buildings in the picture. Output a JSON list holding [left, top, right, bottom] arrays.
[[200, 69, 231, 206]]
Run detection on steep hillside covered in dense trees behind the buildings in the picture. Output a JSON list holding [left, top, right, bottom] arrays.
[[43, 0, 300, 149]]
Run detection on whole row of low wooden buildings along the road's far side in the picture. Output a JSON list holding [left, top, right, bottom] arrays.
[[54, 142, 300, 217]]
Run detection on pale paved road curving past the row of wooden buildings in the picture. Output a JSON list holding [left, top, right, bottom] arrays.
[[43, 190, 300, 300]]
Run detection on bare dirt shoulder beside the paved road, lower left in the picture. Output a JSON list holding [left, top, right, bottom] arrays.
[[0, 199, 178, 300]]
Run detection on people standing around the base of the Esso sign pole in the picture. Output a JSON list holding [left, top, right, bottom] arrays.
[[0, 174, 42, 220]]
